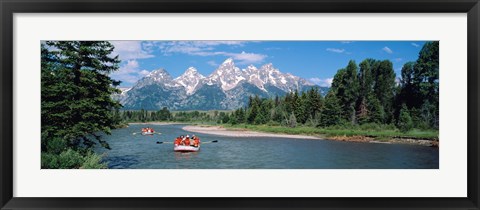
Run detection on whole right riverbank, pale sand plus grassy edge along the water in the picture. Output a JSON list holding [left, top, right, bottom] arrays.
[[183, 125, 439, 147]]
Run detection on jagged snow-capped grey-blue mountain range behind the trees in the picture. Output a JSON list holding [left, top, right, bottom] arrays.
[[114, 58, 328, 110]]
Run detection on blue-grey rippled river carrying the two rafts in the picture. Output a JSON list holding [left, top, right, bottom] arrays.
[[95, 124, 439, 169]]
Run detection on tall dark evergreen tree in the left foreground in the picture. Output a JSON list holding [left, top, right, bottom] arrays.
[[42, 41, 121, 153]]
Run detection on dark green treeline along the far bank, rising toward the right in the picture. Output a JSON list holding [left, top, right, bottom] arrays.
[[121, 42, 439, 131]]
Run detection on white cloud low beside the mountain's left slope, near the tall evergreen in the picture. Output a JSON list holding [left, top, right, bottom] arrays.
[[110, 60, 150, 84]]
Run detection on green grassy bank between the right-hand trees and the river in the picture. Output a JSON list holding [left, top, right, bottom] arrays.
[[222, 124, 438, 140]]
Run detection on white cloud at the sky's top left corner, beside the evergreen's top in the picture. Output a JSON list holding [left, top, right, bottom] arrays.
[[110, 41, 155, 60]]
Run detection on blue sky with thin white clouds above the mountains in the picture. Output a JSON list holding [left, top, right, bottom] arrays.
[[111, 41, 425, 87]]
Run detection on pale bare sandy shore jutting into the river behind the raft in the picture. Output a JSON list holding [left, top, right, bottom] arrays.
[[183, 125, 322, 139]]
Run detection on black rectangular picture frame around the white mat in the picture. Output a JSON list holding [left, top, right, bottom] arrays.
[[0, 0, 480, 209]]
